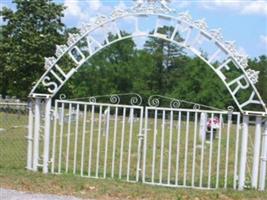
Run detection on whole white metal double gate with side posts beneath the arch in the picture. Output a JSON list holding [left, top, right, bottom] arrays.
[[27, 100, 267, 190]]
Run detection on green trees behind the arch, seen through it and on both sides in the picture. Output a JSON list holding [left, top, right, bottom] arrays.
[[0, 0, 267, 108]]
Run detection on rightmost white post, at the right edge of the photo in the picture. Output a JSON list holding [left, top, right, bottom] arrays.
[[259, 120, 267, 191]]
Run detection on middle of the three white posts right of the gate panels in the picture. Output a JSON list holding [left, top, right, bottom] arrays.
[[251, 116, 261, 188]]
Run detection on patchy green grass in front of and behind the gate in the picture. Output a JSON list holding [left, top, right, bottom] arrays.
[[0, 109, 267, 199]]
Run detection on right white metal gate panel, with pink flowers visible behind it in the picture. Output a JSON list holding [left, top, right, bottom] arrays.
[[143, 107, 240, 188]]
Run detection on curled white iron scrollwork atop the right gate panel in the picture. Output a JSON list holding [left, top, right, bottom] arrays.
[[148, 95, 222, 110]]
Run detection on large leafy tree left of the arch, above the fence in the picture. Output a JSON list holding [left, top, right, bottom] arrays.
[[0, 0, 64, 98]]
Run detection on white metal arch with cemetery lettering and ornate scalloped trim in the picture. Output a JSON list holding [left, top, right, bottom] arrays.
[[30, 1, 267, 113]]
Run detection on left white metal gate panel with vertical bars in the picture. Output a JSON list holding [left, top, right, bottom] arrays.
[[51, 100, 143, 181]]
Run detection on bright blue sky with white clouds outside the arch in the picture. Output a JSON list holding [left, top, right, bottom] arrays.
[[0, 0, 267, 58]]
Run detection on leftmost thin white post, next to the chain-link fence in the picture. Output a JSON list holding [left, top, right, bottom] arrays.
[[27, 100, 33, 170]]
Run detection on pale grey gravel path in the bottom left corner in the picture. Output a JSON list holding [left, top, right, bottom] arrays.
[[0, 188, 83, 200]]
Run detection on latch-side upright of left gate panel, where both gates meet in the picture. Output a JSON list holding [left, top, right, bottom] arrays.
[[136, 107, 144, 182]]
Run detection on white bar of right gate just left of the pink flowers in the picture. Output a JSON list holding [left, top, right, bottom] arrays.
[[199, 113, 207, 187]]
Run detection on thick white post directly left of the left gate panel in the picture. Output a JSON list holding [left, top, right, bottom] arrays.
[[43, 97, 51, 174]]
